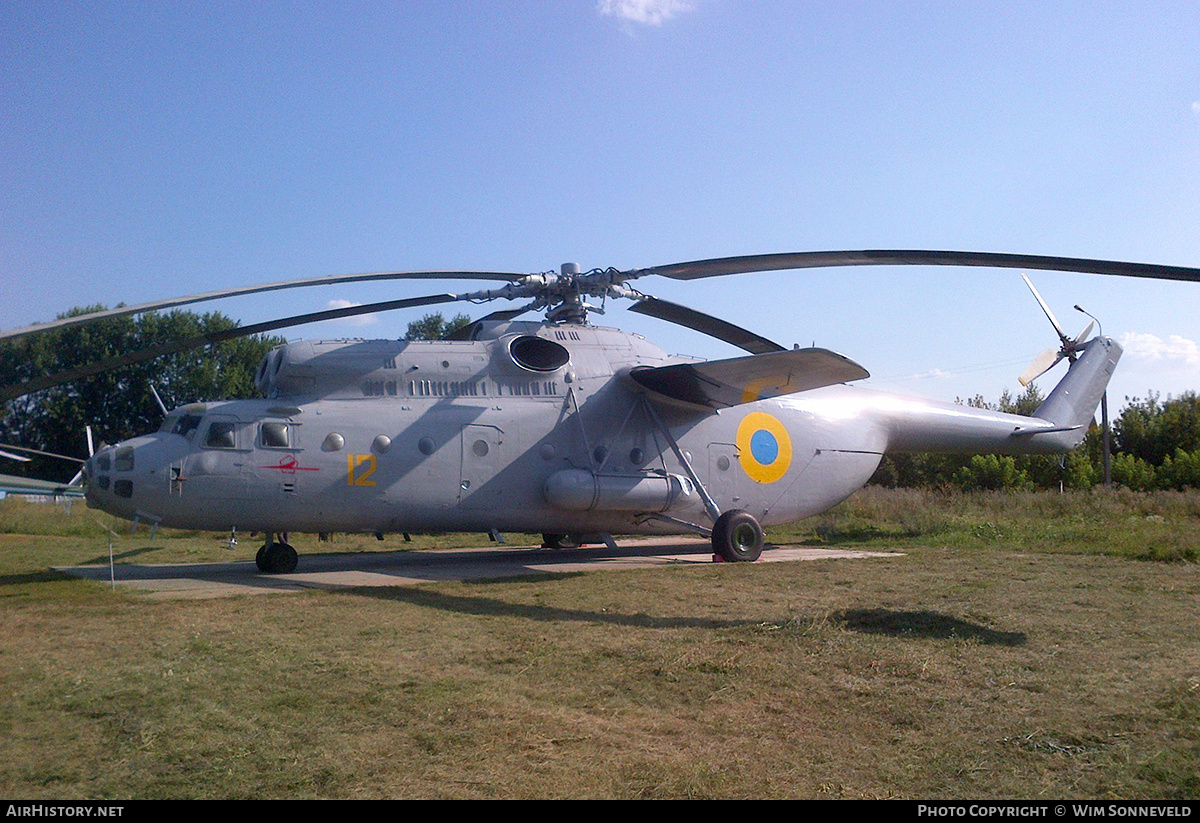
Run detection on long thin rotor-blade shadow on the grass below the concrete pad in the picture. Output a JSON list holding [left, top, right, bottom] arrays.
[[354, 587, 758, 629]]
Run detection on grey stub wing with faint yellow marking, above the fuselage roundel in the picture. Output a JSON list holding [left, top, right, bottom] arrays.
[[630, 349, 870, 409]]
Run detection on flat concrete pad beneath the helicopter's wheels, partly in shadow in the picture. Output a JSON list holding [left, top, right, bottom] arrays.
[[58, 537, 901, 600]]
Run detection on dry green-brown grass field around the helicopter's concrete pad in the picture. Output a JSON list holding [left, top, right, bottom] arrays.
[[0, 489, 1200, 799]]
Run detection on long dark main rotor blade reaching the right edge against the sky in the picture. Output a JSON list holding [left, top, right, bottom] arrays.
[[643, 250, 1200, 282]]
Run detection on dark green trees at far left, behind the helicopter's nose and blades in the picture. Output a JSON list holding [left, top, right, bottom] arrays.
[[0, 306, 283, 480]]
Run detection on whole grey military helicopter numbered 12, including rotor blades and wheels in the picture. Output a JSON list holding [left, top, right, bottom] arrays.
[[0, 251, 1200, 573]]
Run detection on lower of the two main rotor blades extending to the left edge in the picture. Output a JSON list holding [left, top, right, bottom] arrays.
[[0, 294, 461, 403]]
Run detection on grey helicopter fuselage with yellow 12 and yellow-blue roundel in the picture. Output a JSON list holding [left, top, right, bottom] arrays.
[[85, 323, 1115, 542]]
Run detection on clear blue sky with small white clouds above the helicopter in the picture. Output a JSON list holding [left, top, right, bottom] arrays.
[[0, 0, 1200, 408]]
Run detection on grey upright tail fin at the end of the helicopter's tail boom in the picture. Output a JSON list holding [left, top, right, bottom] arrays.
[[1033, 337, 1121, 451]]
